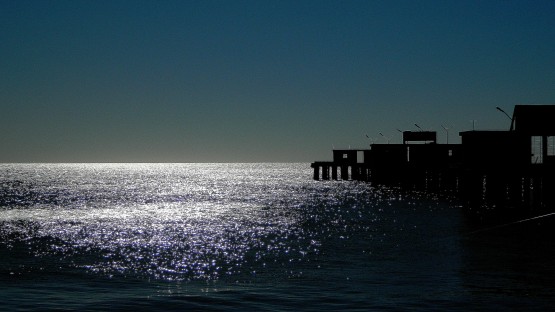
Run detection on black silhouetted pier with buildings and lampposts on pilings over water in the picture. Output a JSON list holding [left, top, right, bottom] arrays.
[[311, 105, 555, 217]]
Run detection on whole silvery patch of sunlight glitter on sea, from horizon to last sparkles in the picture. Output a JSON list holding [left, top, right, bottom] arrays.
[[0, 164, 460, 290]]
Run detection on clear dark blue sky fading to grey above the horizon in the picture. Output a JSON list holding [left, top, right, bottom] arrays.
[[0, 0, 555, 163]]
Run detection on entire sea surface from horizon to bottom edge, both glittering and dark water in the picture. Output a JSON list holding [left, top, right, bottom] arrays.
[[0, 163, 555, 311]]
